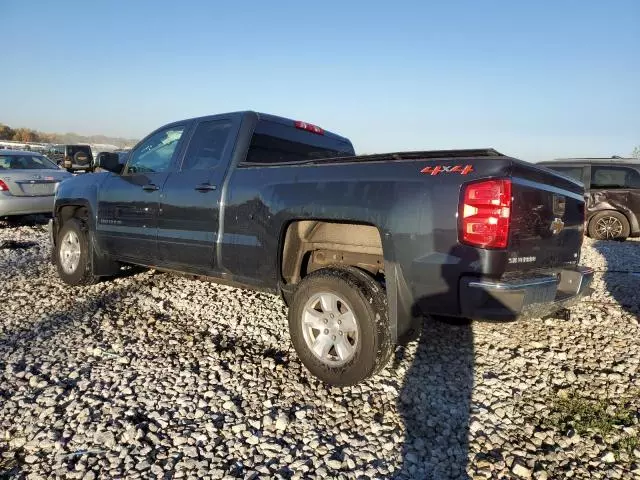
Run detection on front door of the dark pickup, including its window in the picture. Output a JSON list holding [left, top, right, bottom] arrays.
[[97, 125, 185, 265]]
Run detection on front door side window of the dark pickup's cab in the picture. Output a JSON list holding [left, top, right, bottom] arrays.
[[125, 125, 184, 174]]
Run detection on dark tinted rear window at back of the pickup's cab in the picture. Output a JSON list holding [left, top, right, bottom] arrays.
[[245, 120, 354, 164]]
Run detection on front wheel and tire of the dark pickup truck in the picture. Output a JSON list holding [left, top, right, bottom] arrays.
[[54, 218, 100, 286]]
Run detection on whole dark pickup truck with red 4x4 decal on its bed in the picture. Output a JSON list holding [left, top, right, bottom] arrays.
[[51, 112, 592, 385]]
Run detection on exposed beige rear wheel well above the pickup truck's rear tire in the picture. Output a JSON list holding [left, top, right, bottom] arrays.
[[281, 220, 384, 284]]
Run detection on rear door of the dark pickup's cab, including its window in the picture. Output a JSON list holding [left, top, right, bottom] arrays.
[[158, 118, 233, 274]]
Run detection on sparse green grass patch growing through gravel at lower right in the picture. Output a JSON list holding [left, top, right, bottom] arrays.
[[549, 393, 638, 437]]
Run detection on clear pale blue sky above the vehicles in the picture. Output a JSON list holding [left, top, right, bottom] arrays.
[[0, 0, 640, 161]]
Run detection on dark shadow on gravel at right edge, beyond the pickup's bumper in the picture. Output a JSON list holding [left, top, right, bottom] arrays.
[[594, 240, 640, 315]]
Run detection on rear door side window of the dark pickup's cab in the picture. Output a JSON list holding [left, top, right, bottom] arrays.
[[182, 120, 231, 170]]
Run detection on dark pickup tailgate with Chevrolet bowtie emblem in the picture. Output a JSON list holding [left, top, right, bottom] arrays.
[[507, 160, 584, 271]]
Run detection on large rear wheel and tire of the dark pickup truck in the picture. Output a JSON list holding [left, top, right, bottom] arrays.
[[289, 266, 394, 386]]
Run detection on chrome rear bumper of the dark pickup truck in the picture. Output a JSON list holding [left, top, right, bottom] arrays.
[[460, 267, 593, 320]]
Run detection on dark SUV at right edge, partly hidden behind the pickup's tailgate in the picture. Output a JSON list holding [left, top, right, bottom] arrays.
[[540, 157, 640, 240]]
